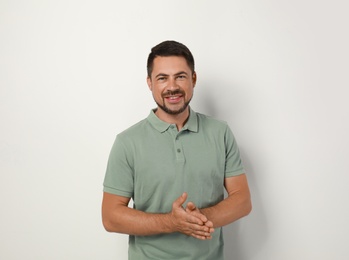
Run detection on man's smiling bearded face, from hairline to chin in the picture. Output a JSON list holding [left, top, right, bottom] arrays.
[[147, 56, 196, 115]]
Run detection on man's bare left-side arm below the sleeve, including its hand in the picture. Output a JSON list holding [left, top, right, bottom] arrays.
[[102, 192, 214, 239]]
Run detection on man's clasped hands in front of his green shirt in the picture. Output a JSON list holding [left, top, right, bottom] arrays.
[[170, 192, 214, 240]]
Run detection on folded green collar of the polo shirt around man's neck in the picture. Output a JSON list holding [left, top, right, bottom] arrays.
[[147, 107, 198, 133]]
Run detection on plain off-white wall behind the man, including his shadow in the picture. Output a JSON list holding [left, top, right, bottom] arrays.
[[0, 0, 349, 260]]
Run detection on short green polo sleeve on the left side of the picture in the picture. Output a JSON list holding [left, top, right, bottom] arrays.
[[103, 136, 134, 198]]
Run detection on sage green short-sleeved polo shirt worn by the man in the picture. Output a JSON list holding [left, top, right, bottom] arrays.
[[104, 109, 244, 260]]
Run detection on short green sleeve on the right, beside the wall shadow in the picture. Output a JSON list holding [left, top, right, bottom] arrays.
[[224, 125, 245, 178]]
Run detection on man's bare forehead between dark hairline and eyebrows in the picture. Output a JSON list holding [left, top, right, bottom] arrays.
[[152, 56, 190, 75]]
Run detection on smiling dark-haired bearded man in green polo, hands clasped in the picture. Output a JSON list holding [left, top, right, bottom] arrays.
[[102, 41, 251, 260]]
